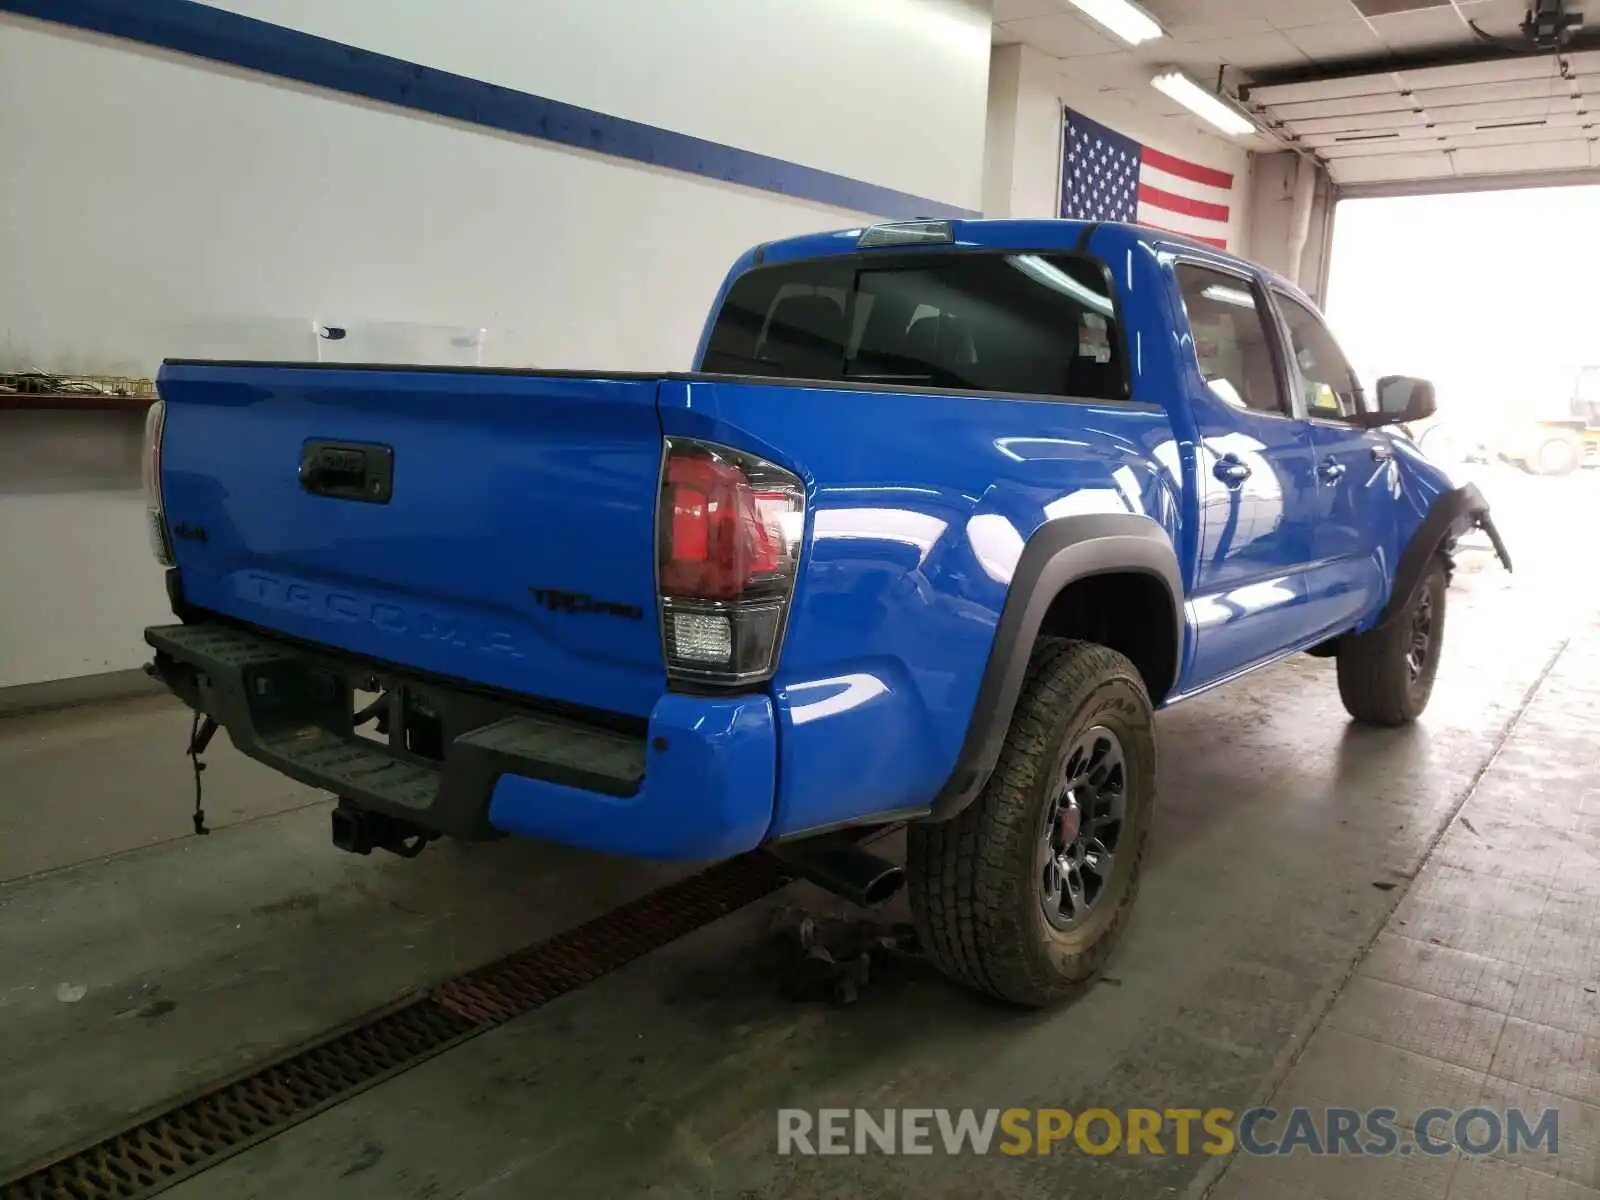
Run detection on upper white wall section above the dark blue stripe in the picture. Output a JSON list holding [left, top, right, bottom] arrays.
[[193, 0, 989, 210]]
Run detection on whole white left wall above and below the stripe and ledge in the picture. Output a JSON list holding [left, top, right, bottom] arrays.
[[0, 0, 989, 688]]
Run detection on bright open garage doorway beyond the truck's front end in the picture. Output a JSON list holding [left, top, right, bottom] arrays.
[[1326, 176, 1600, 595]]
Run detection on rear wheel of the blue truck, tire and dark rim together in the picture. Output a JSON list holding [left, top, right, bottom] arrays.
[[907, 642, 1155, 1006]]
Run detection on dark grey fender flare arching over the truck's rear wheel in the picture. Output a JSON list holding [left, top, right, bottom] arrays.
[[926, 512, 1184, 821]]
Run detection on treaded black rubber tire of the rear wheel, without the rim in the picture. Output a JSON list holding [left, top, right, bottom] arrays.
[[906, 640, 1155, 1006]]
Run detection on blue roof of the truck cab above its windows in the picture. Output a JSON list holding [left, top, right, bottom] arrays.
[[739, 218, 1310, 310]]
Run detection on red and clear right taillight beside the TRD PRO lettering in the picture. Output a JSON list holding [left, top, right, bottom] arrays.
[[656, 437, 805, 683]]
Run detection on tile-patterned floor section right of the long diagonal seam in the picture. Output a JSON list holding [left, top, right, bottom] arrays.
[[1216, 622, 1600, 1200]]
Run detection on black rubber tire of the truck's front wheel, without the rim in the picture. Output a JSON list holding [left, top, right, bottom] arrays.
[[1338, 557, 1448, 728]]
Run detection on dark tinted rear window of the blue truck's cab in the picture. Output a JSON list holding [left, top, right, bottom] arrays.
[[701, 253, 1128, 400]]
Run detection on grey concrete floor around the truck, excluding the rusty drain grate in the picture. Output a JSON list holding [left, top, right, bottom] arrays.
[[0, 474, 1600, 1200]]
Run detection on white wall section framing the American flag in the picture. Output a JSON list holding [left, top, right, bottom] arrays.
[[984, 45, 1250, 250]]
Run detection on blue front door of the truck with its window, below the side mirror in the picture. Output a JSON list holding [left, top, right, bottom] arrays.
[[1272, 290, 1398, 635]]
